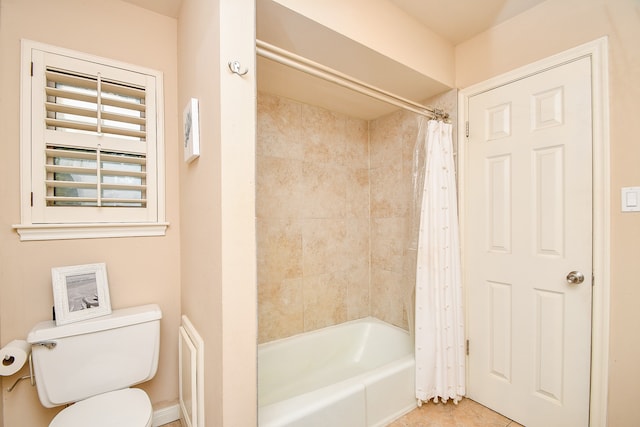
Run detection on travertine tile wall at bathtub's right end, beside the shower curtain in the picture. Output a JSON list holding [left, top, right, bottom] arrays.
[[369, 111, 418, 328]]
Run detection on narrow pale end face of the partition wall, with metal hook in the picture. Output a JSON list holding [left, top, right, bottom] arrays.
[[219, 0, 258, 427]]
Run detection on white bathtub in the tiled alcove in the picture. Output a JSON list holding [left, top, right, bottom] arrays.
[[258, 317, 416, 427]]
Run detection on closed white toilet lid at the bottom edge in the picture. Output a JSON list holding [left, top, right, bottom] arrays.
[[49, 388, 153, 427]]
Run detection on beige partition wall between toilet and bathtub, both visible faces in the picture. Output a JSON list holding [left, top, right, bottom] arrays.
[[178, 0, 257, 426]]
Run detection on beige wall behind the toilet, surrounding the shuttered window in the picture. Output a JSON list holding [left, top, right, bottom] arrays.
[[0, 0, 180, 427]]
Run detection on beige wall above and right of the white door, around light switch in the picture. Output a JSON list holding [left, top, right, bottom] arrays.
[[456, 0, 640, 427]]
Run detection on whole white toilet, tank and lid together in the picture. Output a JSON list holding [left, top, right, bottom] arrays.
[[27, 304, 162, 427]]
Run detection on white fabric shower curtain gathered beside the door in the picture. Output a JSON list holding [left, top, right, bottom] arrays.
[[414, 118, 465, 404]]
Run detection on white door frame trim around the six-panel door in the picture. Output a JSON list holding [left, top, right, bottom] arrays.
[[457, 37, 611, 427]]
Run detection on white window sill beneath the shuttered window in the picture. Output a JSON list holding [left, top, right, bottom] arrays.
[[13, 222, 169, 241]]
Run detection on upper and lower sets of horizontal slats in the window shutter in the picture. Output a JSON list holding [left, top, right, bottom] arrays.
[[45, 67, 146, 207]]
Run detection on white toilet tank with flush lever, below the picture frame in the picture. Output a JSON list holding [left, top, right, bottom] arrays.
[[27, 304, 162, 408]]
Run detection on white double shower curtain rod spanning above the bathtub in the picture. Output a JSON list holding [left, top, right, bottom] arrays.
[[256, 39, 449, 120]]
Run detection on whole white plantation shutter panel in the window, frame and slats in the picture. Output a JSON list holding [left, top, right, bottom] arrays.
[[32, 48, 157, 222]]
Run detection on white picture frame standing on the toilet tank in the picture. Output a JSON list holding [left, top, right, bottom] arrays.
[[51, 263, 111, 326]]
